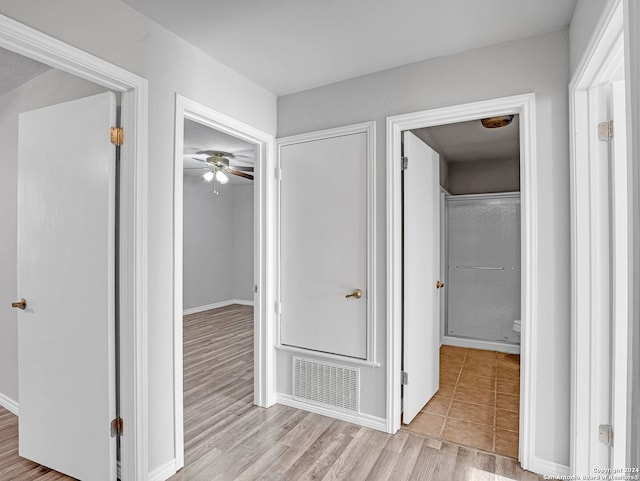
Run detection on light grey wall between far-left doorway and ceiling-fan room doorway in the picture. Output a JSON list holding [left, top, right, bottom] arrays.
[[0, 0, 276, 471]]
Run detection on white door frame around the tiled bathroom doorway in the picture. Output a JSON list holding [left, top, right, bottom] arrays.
[[387, 93, 539, 469]]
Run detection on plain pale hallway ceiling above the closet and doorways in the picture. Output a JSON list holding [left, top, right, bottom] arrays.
[[124, 0, 576, 95]]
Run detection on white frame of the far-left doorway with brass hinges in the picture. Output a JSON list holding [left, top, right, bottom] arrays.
[[0, 14, 148, 481]]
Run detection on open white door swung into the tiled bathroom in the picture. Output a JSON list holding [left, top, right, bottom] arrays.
[[402, 132, 441, 424]]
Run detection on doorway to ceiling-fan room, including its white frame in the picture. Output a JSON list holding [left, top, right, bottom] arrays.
[[174, 95, 275, 470]]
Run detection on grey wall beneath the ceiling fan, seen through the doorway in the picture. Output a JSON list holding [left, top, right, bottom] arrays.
[[183, 176, 253, 309]]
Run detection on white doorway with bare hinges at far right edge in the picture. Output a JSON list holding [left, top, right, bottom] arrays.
[[569, 1, 635, 477]]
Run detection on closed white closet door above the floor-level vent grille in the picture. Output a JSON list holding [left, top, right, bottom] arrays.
[[279, 132, 368, 359]]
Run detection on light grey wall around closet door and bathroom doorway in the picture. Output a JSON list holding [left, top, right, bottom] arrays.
[[277, 30, 570, 465]]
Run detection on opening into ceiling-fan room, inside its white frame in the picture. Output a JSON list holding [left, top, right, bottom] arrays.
[[183, 119, 257, 465]]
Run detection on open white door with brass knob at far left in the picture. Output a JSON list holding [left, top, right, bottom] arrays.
[[18, 92, 116, 481]]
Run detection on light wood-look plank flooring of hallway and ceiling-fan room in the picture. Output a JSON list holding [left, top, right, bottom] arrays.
[[170, 306, 542, 481]]
